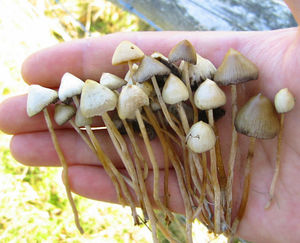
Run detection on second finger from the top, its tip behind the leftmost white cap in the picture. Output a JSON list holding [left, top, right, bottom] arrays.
[[0, 95, 104, 134]]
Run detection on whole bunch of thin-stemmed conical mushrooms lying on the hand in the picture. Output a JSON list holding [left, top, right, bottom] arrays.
[[27, 40, 294, 243]]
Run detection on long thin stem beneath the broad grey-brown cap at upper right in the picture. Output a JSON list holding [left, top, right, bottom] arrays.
[[226, 84, 238, 225]]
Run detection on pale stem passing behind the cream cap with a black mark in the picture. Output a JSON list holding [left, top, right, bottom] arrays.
[[208, 109, 221, 234]]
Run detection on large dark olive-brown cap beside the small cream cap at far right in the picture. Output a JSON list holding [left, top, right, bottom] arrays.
[[234, 94, 280, 139]]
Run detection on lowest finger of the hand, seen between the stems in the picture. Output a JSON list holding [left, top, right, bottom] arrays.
[[69, 166, 184, 213]]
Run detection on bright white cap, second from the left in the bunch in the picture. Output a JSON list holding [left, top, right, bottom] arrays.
[[58, 73, 84, 101]]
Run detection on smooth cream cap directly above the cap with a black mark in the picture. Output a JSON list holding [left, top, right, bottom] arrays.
[[194, 79, 226, 110]]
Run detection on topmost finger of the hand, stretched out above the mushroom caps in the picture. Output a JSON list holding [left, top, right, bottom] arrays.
[[22, 32, 251, 87]]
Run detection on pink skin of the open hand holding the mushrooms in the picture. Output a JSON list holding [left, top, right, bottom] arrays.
[[0, 1, 300, 242]]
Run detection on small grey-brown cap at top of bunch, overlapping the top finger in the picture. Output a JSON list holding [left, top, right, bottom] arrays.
[[168, 40, 197, 65]]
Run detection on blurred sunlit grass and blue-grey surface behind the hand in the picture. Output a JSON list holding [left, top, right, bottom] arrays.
[[0, 0, 296, 242]]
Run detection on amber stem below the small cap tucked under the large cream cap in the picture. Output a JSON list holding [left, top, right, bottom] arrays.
[[85, 126, 139, 225]]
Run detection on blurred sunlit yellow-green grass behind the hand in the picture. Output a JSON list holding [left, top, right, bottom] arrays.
[[0, 0, 229, 243]]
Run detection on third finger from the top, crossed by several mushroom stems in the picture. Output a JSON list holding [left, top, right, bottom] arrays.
[[10, 129, 163, 168]]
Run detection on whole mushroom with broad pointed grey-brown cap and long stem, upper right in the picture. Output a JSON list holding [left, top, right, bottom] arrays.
[[214, 48, 258, 225]]
